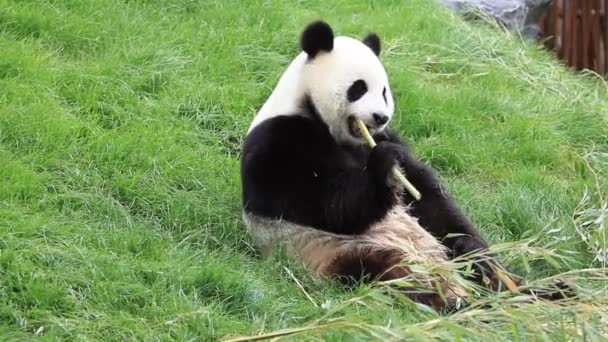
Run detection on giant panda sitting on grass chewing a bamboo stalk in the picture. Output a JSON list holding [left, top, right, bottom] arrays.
[[241, 21, 564, 310]]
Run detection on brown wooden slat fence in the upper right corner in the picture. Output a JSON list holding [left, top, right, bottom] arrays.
[[540, 0, 608, 75]]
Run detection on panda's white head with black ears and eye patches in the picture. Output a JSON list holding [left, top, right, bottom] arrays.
[[301, 21, 394, 144]]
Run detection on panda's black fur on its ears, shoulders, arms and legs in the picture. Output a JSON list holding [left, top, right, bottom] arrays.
[[241, 22, 572, 307]]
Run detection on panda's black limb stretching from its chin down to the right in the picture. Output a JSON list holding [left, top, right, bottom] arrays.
[[375, 130, 487, 252]]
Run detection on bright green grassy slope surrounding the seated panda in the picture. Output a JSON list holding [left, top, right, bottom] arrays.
[[0, 0, 608, 340]]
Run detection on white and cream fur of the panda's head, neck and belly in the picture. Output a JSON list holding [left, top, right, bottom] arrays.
[[242, 21, 466, 307]]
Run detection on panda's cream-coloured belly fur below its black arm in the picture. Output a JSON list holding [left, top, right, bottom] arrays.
[[243, 200, 447, 275]]
